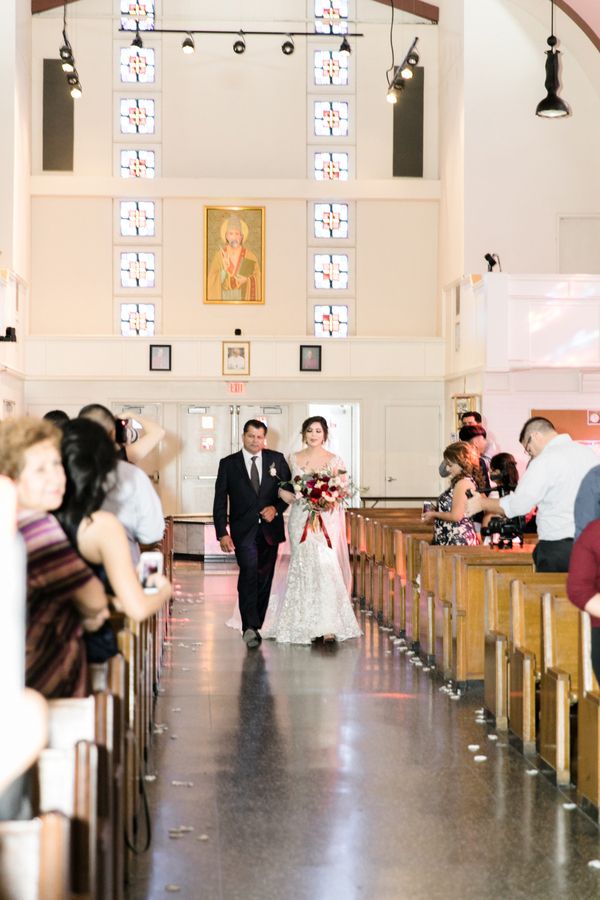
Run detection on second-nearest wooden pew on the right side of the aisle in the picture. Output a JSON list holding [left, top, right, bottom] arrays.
[[540, 592, 579, 784]]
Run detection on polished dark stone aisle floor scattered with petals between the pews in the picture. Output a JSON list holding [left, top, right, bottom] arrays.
[[127, 563, 600, 900]]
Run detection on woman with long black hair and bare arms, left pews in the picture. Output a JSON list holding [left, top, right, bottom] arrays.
[[56, 419, 171, 644]]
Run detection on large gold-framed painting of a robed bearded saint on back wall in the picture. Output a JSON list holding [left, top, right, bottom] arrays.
[[204, 206, 265, 304]]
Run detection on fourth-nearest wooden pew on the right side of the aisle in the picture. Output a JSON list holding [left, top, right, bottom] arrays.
[[483, 568, 567, 731]]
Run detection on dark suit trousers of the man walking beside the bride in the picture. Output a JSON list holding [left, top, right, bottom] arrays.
[[235, 525, 279, 631]]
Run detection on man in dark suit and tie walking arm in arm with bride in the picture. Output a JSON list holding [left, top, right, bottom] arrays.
[[213, 419, 291, 649]]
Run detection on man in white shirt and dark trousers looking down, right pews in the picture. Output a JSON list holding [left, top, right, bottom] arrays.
[[467, 417, 598, 572]]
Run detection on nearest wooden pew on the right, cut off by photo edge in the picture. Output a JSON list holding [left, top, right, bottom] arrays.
[[577, 612, 600, 820]]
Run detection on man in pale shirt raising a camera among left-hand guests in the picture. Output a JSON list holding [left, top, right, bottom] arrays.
[[79, 403, 165, 563]]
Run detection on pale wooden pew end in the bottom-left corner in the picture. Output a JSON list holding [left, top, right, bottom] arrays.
[[0, 812, 71, 900]]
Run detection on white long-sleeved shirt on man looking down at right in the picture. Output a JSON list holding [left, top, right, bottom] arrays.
[[500, 434, 598, 541]]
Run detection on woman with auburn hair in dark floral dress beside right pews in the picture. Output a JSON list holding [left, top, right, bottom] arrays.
[[423, 441, 481, 546]]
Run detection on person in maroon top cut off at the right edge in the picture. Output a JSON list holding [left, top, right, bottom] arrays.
[[567, 520, 600, 681]]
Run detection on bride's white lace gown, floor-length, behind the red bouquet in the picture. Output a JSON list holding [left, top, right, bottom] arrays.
[[261, 457, 362, 644]]
